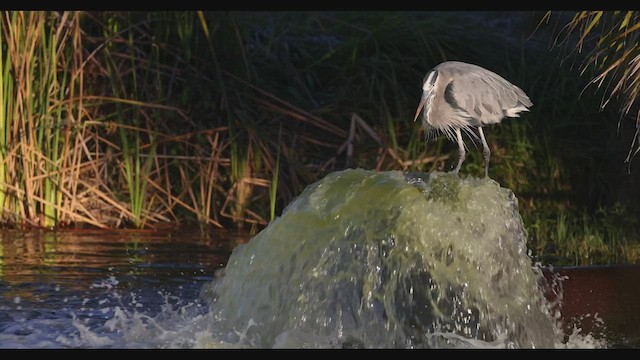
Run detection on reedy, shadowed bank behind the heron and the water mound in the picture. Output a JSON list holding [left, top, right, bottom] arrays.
[[0, 11, 640, 264]]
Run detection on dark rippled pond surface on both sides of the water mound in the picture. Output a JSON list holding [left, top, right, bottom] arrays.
[[0, 229, 640, 348]]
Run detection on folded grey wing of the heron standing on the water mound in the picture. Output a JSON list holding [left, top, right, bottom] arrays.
[[448, 68, 533, 124]]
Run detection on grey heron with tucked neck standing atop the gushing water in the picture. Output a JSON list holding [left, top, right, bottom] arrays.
[[413, 61, 533, 177]]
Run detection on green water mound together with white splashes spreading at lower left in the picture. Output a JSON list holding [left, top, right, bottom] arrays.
[[0, 169, 604, 348]]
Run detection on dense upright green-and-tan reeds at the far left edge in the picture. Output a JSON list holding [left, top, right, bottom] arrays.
[[0, 11, 93, 227]]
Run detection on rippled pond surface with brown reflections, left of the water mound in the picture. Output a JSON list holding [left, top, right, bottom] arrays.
[[0, 229, 241, 348]]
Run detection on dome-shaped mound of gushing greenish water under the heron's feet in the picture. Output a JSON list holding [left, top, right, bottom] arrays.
[[203, 169, 562, 348]]
